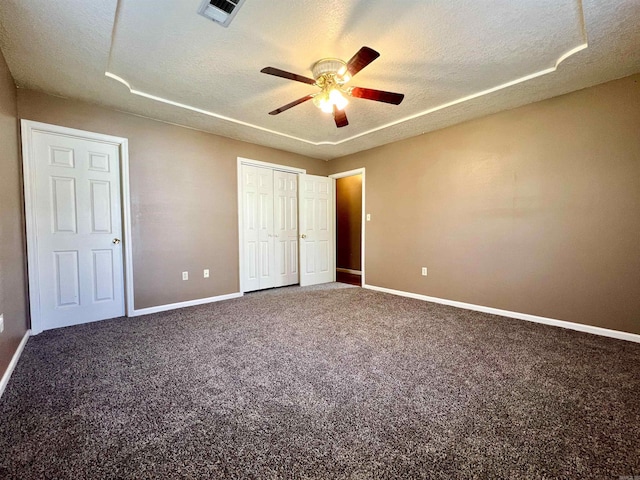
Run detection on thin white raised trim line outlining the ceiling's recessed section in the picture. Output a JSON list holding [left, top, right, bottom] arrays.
[[105, 0, 589, 146]]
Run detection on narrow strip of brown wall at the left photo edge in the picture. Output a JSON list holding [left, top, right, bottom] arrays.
[[0, 52, 28, 377]]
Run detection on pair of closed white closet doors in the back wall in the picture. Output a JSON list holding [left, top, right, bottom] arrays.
[[241, 165, 299, 292]]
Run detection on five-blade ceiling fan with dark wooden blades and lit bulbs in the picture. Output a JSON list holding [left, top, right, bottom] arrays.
[[260, 47, 404, 128]]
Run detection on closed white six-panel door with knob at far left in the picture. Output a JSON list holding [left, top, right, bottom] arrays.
[[30, 131, 124, 330]]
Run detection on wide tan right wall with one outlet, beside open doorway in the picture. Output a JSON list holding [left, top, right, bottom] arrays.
[[329, 75, 640, 333]]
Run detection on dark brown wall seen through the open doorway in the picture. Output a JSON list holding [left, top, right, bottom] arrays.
[[336, 175, 362, 270]]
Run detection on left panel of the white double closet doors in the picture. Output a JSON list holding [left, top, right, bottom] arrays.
[[242, 165, 275, 292]]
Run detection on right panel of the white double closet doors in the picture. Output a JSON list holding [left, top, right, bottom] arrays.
[[273, 170, 298, 287]]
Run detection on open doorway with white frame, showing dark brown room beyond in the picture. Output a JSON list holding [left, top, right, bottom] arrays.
[[332, 169, 365, 286]]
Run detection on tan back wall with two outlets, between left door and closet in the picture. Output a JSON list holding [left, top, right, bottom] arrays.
[[18, 89, 327, 309]]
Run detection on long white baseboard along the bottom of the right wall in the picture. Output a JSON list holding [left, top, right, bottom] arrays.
[[362, 285, 640, 343]]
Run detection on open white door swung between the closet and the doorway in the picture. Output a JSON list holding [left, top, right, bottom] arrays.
[[299, 175, 335, 286]]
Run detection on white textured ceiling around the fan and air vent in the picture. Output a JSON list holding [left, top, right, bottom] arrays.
[[0, 0, 640, 159]]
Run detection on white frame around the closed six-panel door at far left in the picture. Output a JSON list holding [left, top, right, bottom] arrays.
[[20, 120, 134, 335]]
